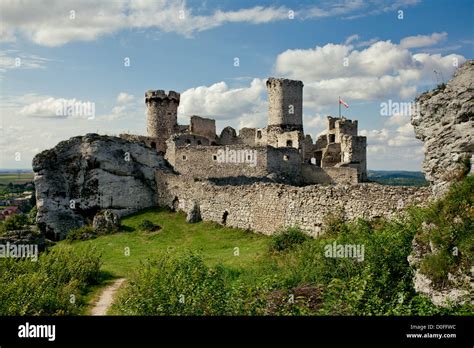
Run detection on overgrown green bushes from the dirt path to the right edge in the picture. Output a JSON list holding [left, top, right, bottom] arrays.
[[115, 177, 474, 315]]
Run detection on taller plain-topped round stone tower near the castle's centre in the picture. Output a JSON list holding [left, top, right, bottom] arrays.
[[267, 77, 303, 131]]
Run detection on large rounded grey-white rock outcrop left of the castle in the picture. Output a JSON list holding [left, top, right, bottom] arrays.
[[33, 134, 164, 240]]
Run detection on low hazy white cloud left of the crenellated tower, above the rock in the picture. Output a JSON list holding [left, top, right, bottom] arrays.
[[0, 93, 146, 168]]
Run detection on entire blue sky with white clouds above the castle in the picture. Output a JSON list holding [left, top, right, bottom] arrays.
[[0, 0, 474, 170]]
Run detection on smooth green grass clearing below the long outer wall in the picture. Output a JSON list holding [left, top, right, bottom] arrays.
[[54, 209, 269, 278]]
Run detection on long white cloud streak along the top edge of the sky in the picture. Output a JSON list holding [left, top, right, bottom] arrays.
[[0, 0, 422, 46]]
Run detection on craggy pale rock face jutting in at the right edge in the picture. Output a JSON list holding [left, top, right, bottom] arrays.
[[411, 60, 474, 194]]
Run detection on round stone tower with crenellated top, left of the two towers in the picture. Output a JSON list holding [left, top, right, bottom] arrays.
[[145, 90, 180, 152]]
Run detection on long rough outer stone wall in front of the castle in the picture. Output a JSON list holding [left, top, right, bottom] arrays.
[[156, 171, 430, 236]]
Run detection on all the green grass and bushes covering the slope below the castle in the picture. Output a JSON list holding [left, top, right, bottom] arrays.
[[0, 176, 474, 315]]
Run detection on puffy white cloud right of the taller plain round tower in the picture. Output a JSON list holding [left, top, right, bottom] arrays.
[[275, 34, 465, 110]]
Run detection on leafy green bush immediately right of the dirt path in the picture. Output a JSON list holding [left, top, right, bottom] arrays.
[[114, 253, 265, 315]]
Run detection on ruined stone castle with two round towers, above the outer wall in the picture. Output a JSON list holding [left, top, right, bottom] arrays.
[[120, 77, 367, 185]]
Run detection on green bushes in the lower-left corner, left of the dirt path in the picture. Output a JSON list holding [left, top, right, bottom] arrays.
[[0, 248, 101, 315]]
